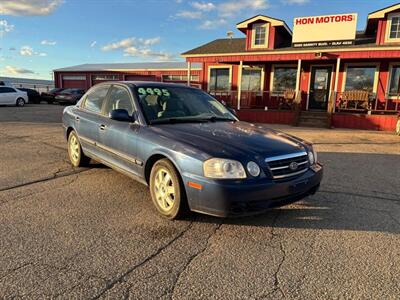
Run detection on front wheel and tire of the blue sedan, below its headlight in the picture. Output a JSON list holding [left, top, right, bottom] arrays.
[[150, 159, 188, 220]]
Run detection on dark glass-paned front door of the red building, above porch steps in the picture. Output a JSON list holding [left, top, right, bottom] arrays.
[[308, 67, 332, 110]]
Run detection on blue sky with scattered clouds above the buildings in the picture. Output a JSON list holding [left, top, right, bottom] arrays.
[[0, 0, 397, 79]]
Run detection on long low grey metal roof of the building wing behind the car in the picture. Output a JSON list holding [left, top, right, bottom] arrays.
[[54, 62, 201, 71]]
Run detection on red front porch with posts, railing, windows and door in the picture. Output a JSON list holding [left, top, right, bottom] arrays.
[[195, 58, 400, 130]]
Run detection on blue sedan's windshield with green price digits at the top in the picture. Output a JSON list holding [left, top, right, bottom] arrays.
[[135, 85, 237, 124]]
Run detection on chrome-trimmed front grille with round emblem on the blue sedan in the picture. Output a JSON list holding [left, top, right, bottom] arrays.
[[265, 151, 309, 179]]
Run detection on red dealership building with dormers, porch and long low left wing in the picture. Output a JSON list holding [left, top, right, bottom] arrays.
[[55, 4, 400, 130]]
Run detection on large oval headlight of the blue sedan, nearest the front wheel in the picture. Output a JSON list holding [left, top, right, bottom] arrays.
[[203, 158, 246, 179]]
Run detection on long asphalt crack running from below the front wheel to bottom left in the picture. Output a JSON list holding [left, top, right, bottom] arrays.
[[91, 222, 193, 300]]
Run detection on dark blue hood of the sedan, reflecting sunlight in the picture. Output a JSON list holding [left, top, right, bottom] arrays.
[[150, 122, 306, 159]]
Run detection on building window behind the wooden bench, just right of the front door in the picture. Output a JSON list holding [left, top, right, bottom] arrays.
[[344, 66, 376, 93]]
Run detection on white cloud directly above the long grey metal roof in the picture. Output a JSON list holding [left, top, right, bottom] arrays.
[[101, 37, 176, 60]]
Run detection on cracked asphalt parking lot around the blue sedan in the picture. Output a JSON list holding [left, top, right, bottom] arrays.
[[0, 104, 400, 299]]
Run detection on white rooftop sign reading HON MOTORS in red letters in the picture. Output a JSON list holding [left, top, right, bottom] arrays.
[[292, 14, 357, 48]]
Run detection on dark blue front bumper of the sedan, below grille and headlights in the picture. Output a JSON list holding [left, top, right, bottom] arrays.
[[184, 164, 323, 217]]
